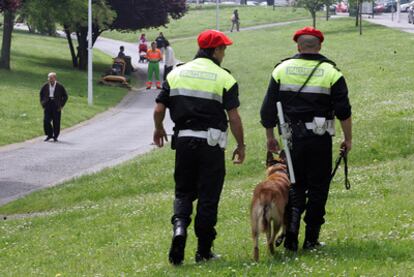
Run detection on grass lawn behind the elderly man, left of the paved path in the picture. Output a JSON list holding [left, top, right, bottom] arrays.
[[0, 31, 127, 145]]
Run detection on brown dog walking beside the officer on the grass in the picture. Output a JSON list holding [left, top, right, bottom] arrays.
[[250, 151, 290, 261]]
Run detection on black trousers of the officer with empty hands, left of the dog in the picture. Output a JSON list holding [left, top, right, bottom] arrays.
[[172, 137, 225, 242]]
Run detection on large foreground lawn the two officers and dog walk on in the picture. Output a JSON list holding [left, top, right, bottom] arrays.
[[0, 19, 414, 276]]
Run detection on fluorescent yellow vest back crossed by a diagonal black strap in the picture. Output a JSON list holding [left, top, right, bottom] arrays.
[[272, 59, 342, 95]]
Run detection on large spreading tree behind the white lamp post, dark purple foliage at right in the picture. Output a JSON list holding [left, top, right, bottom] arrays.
[[20, 0, 187, 69]]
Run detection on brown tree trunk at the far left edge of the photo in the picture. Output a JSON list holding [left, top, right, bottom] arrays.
[[0, 0, 21, 70]]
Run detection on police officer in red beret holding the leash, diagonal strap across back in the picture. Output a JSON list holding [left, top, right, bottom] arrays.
[[260, 27, 352, 251]]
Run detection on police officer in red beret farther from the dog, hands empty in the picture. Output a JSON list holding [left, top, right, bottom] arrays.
[[154, 30, 245, 265]]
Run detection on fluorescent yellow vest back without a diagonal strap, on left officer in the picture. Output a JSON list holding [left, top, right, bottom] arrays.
[[167, 58, 236, 103]]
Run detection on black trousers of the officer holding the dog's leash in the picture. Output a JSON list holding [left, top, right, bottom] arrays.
[[289, 134, 332, 226]]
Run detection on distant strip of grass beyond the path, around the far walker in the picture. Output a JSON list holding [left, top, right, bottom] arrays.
[[103, 5, 316, 43]]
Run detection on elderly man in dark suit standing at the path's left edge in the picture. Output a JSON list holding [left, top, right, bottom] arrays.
[[40, 72, 68, 141]]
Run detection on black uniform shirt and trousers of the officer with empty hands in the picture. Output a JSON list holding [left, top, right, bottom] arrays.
[[156, 54, 240, 263]]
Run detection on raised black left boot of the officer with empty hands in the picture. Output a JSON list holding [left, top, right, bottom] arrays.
[[168, 219, 187, 265]]
